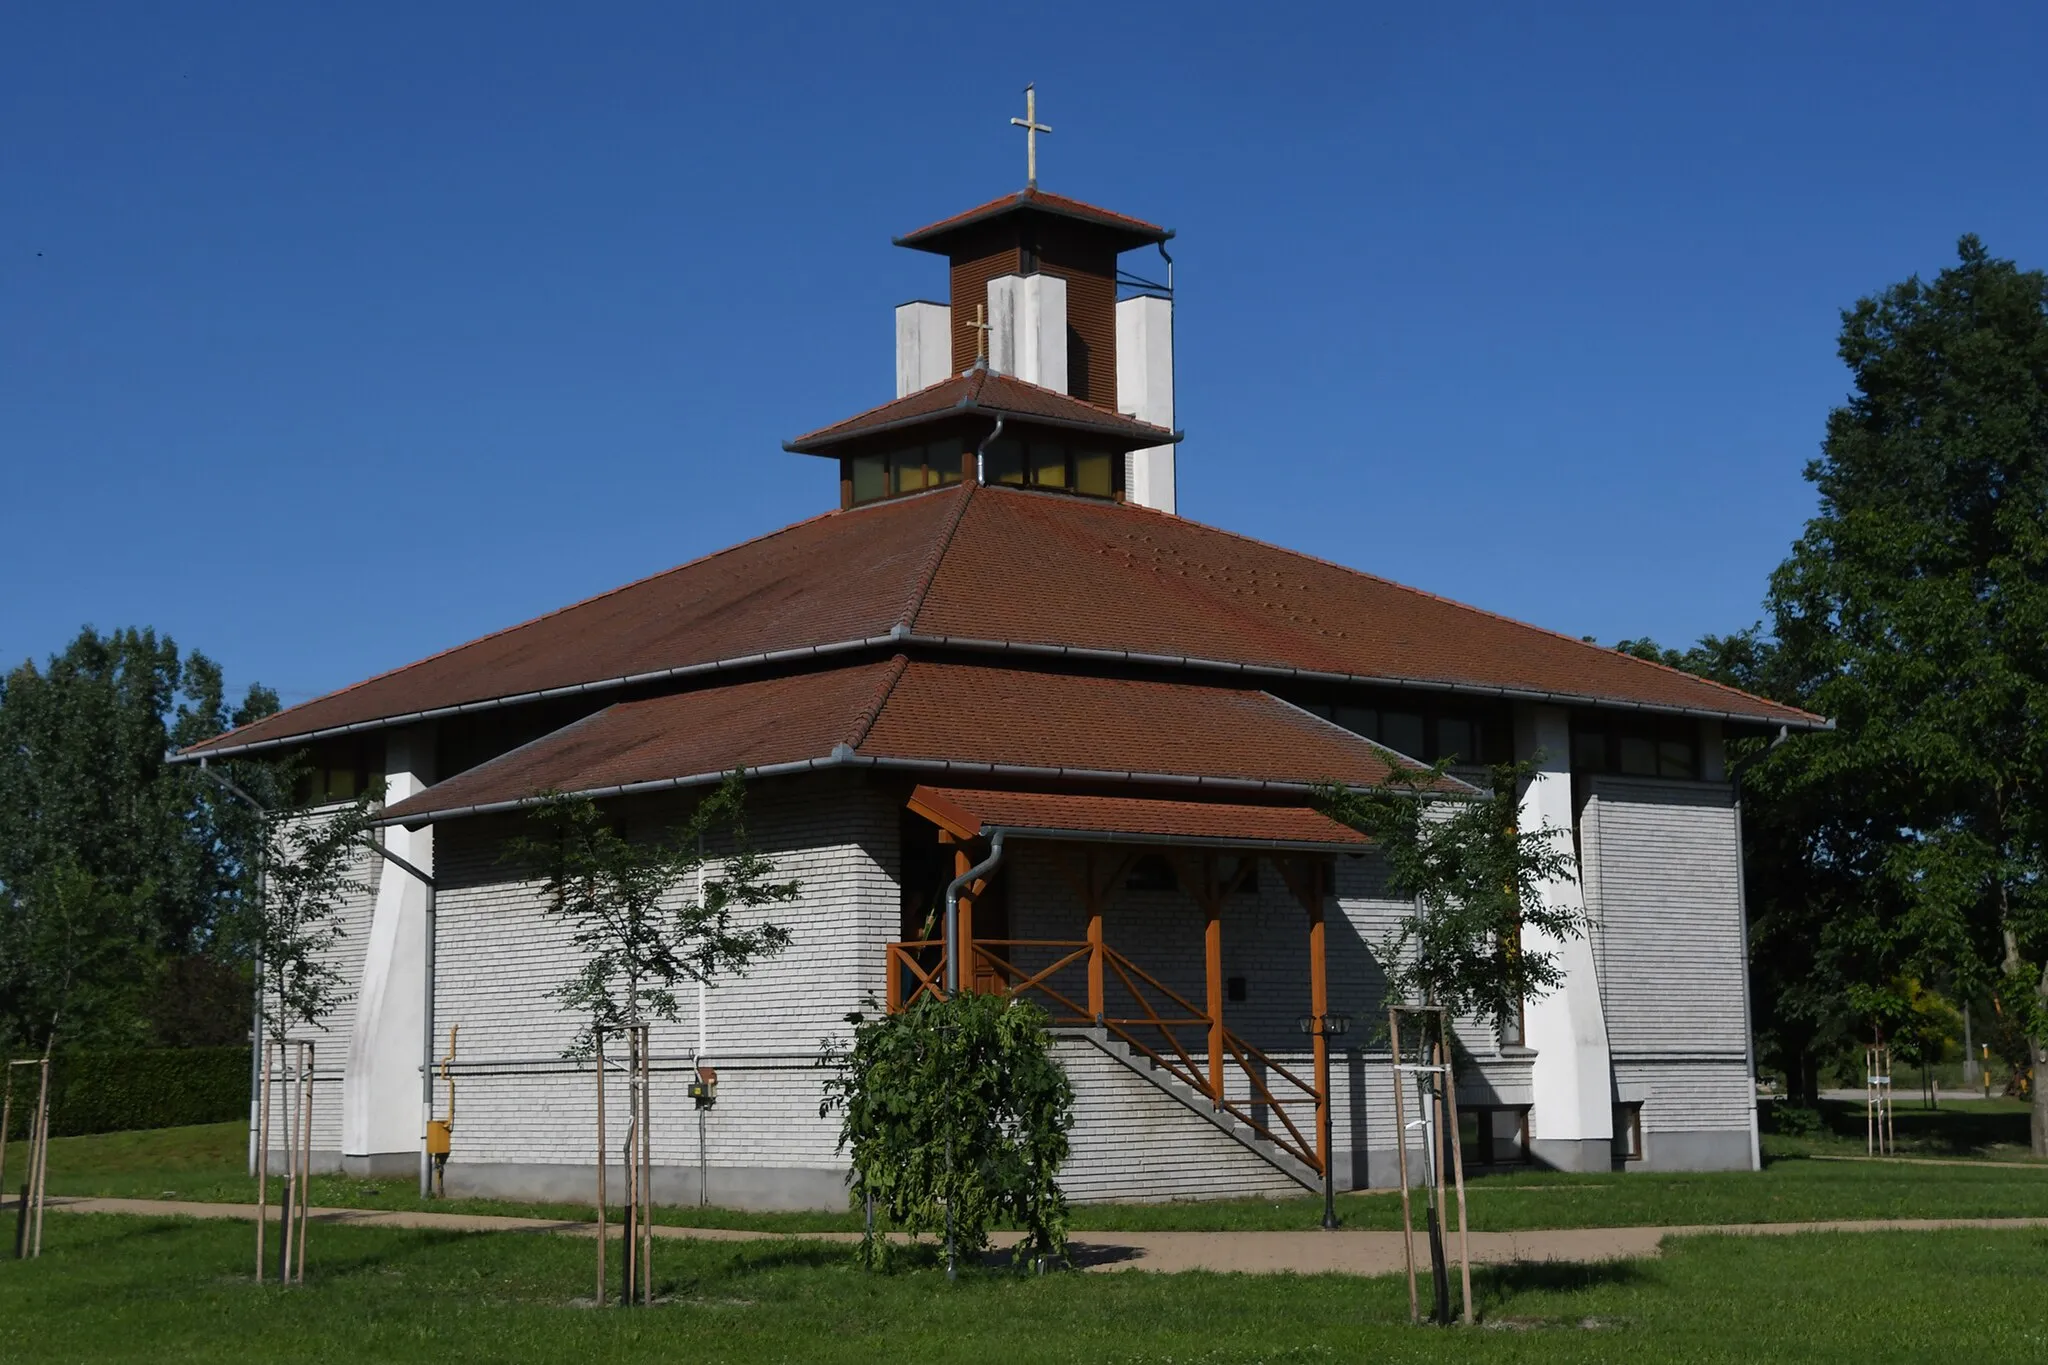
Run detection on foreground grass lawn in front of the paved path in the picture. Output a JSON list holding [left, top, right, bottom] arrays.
[[0, 1214, 2048, 1365]]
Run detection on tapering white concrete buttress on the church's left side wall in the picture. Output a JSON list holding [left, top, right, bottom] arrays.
[[342, 726, 434, 1175]]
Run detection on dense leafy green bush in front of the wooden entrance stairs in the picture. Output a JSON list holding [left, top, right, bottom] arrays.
[[819, 993, 1073, 1267]]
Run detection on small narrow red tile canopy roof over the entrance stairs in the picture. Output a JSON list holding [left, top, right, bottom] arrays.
[[911, 786, 1368, 849]]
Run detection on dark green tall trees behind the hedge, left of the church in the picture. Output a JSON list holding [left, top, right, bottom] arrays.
[[0, 628, 276, 1042]]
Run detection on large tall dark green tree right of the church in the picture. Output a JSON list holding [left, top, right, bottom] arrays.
[[1769, 237, 2048, 1156]]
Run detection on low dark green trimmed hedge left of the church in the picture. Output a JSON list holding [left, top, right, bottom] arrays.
[[8, 1046, 250, 1138]]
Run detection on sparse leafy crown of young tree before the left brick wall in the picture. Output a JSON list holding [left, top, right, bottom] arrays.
[[508, 772, 801, 1054]]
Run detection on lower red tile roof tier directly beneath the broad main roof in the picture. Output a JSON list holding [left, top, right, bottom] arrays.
[[385, 655, 1464, 821]]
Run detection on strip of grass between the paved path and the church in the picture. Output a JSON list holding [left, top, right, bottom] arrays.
[[8, 1101, 2048, 1232]]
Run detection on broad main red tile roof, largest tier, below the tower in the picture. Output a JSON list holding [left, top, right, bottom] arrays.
[[186, 485, 1821, 755]]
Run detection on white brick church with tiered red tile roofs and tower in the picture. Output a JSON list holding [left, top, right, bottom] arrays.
[[180, 136, 1825, 1207]]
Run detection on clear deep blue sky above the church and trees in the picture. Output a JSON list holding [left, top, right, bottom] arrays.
[[0, 2, 2048, 702]]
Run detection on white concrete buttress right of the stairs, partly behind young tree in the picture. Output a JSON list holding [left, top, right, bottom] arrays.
[[1516, 706, 1614, 1171]]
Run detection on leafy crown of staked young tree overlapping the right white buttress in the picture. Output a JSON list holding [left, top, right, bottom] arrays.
[[1317, 763, 1585, 1027]]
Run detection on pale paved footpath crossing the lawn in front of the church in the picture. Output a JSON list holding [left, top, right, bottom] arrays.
[[28, 1195, 2048, 1275]]
